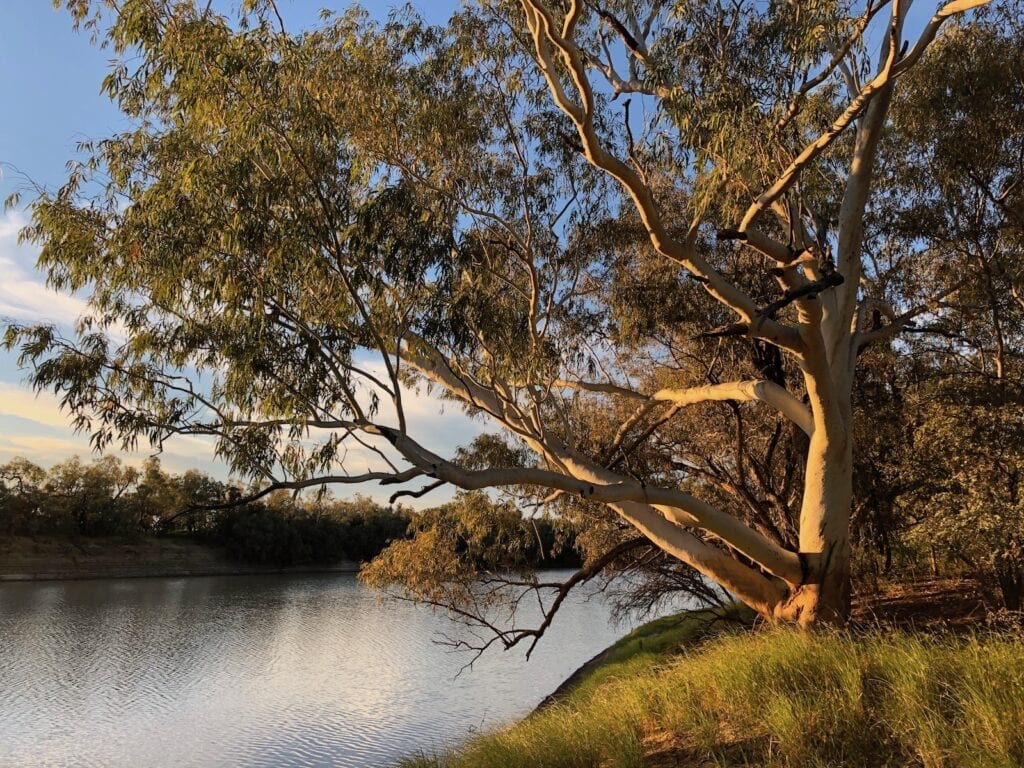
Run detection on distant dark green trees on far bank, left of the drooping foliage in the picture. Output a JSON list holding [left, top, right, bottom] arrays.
[[0, 457, 412, 566]]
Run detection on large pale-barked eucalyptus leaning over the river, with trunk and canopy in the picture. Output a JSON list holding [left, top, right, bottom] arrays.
[[7, 0, 984, 630]]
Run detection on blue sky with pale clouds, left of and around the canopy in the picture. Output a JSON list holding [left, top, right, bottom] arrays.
[[0, 0, 468, 503]]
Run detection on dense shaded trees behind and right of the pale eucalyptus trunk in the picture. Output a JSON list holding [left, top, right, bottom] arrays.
[[855, 2, 1024, 609]]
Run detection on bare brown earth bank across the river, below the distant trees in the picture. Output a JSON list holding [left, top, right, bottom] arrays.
[[0, 537, 359, 582]]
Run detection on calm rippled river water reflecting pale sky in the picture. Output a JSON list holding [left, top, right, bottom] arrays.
[[0, 575, 663, 768]]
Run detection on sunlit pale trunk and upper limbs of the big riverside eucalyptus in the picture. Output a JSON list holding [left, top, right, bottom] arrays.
[[520, 0, 988, 626]]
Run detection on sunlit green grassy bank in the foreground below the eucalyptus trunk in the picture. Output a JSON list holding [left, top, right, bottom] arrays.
[[403, 617, 1024, 768]]
